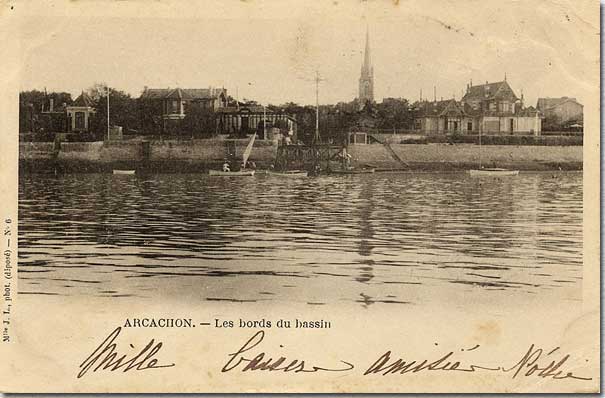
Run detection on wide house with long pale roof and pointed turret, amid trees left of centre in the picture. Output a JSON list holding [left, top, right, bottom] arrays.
[[139, 87, 228, 132]]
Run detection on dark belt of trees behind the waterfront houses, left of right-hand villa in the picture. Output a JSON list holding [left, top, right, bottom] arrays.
[[19, 84, 414, 143]]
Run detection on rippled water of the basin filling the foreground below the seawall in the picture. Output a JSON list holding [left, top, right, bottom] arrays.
[[19, 173, 582, 308]]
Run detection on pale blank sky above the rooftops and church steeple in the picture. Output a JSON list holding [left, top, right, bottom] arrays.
[[15, 0, 599, 106]]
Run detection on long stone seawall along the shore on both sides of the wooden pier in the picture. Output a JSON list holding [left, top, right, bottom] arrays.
[[19, 140, 583, 173]]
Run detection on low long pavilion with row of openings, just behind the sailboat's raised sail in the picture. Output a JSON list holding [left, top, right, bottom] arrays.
[[216, 104, 297, 141]]
